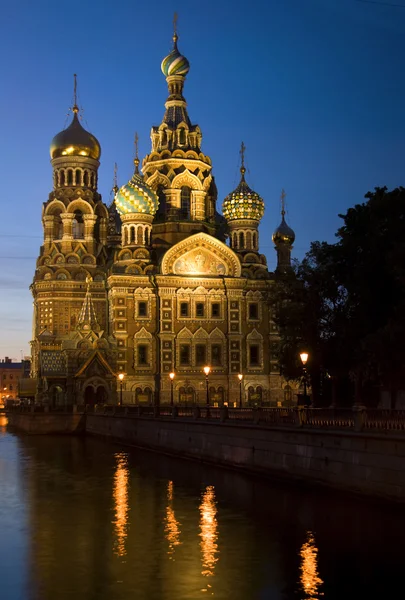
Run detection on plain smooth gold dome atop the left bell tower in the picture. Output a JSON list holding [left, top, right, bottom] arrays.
[[50, 106, 101, 160]]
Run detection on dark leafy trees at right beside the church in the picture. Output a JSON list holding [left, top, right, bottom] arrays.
[[272, 187, 405, 404]]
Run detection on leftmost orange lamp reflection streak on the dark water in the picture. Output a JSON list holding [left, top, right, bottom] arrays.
[[113, 452, 129, 556]]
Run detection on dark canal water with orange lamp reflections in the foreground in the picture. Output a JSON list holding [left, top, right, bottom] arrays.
[[0, 416, 405, 600]]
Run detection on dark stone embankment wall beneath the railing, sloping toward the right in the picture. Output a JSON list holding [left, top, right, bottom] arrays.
[[86, 413, 405, 501]]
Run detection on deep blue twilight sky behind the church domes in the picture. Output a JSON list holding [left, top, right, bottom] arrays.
[[0, 0, 405, 359]]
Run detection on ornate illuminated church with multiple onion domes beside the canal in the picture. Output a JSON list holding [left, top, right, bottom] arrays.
[[31, 25, 296, 406]]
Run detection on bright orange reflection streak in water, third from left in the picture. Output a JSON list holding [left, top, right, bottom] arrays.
[[200, 485, 218, 577]]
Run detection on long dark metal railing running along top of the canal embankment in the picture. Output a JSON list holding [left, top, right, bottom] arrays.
[[6, 404, 405, 433]]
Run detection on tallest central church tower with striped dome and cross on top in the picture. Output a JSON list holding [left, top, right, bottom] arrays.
[[142, 18, 217, 249]]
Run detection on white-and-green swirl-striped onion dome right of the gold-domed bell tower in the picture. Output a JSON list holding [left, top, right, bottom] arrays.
[[114, 158, 159, 216]]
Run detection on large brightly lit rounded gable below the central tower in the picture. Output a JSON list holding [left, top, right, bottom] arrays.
[[162, 232, 241, 277]]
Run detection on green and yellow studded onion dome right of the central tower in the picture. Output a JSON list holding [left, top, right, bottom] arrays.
[[222, 166, 264, 221]]
